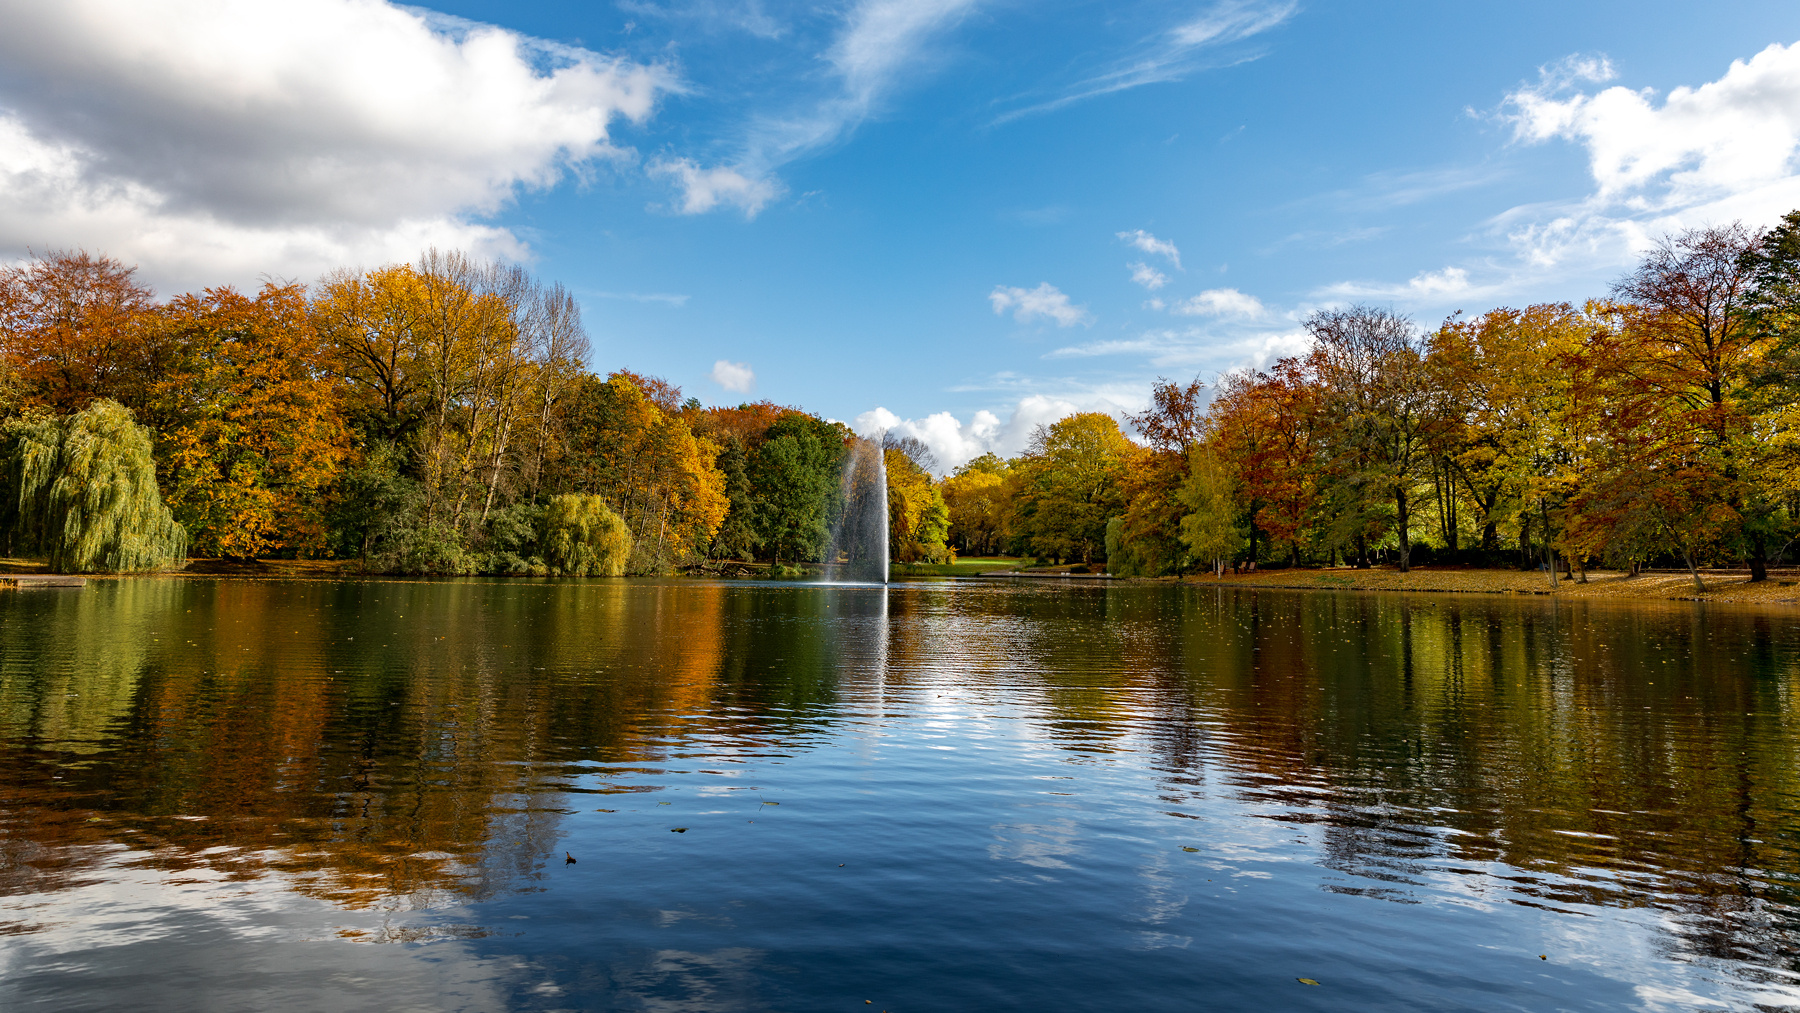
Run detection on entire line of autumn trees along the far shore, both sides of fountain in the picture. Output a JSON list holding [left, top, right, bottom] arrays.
[[0, 212, 1800, 583]]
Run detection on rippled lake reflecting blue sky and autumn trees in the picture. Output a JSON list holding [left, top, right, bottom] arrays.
[[0, 578, 1800, 1013]]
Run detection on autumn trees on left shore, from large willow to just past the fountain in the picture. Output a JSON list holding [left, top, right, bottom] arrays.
[[0, 250, 949, 574]]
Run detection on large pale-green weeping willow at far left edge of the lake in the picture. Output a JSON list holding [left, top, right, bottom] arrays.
[[0, 401, 187, 574]]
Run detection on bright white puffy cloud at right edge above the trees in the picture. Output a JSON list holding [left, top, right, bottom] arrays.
[[1496, 43, 1800, 268]]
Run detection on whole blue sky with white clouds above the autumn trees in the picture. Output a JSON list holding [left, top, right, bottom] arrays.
[[0, 0, 1800, 462]]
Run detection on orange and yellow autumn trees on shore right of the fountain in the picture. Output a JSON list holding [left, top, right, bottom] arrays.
[[943, 212, 1800, 585]]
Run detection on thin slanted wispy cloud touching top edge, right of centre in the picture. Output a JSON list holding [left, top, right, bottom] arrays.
[[994, 0, 1300, 124]]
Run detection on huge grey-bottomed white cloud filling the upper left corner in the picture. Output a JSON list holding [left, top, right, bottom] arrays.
[[0, 0, 679, 284]]
